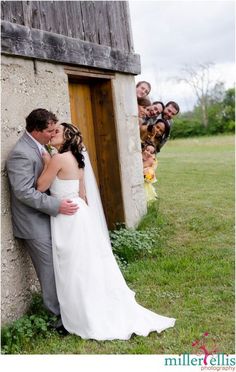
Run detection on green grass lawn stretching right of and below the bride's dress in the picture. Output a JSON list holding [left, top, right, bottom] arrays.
[[4, 136, 234, 354]]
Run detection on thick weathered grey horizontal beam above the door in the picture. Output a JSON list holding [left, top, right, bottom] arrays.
[[1, 21, 141, 75]]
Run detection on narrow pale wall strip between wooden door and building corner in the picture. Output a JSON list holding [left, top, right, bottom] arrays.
[[112, 73, 147, 227]]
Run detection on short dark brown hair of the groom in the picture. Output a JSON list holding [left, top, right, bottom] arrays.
[[26, 108, 58, 133]]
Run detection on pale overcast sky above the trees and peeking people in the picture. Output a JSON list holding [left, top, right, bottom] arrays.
[[129, 0, 235, 111]]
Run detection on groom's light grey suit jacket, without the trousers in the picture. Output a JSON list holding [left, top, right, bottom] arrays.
[[6, 133, 60, 239]]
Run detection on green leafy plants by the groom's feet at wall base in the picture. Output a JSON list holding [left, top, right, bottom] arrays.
[[1, 294, 56, 354]]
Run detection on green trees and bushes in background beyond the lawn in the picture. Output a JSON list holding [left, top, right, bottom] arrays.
[[171, 87, 235, 139]]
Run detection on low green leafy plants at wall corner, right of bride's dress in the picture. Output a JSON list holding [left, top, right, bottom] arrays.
[[110, 227, 158, 265]]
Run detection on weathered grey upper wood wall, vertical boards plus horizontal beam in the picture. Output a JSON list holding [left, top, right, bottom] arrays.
[[1, 1, 141, 75]]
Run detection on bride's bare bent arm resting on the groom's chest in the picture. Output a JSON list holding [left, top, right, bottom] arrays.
[[37, 153, 61, 192]]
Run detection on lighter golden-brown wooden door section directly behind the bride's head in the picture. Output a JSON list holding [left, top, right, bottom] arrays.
[[69, 82, 100, 186]]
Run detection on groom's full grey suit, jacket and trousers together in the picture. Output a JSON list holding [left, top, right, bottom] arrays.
[[7, 133, 60, 315]]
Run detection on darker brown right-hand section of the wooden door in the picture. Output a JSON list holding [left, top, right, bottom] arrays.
[[91, 80, 125, 228]]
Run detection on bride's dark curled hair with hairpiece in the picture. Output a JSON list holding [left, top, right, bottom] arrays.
[[58, 123, 85, 168]]
